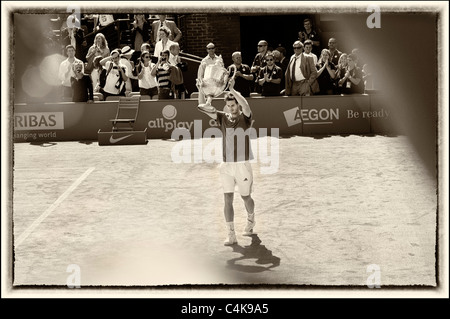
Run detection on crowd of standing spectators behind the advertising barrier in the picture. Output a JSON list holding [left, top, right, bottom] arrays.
[[48, 13, 375, 103]]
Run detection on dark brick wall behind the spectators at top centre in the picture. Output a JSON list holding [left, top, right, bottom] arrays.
[[181, 13, 241, 66]]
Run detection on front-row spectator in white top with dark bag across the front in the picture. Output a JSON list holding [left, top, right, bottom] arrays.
[[100, 49, 128, 100]]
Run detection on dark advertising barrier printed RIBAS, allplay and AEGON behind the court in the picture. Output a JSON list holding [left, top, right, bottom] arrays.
[[13, 95, 393, 142]]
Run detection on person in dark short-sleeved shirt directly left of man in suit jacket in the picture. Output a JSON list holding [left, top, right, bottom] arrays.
[[258, 52, 283, 96]]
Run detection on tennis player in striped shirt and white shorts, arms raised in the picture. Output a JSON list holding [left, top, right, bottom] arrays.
[[198, 79, 255, 246]]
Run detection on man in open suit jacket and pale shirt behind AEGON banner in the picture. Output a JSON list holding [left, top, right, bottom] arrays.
[[285, 41, 319, 96]]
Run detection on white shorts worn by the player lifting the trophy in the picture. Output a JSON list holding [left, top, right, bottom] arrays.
[[220, 162, 253, 196]]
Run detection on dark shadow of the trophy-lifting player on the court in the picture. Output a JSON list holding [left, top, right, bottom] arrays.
[[227, 235, 281, 273]]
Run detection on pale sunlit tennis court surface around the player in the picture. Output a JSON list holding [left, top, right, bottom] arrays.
[[13, 135, 437, 287]]
